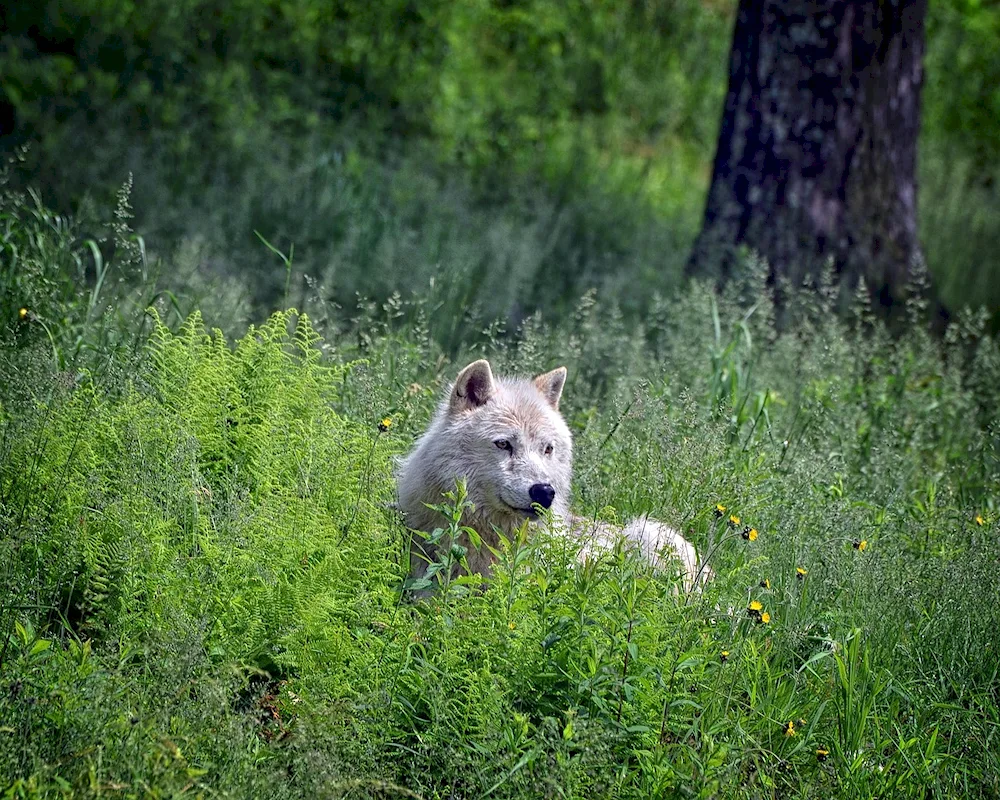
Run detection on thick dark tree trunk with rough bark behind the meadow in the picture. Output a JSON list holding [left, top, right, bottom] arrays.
[[688, 0, 927, 303]]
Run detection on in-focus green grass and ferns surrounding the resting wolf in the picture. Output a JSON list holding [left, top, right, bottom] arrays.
[[0, 184, 1000, 798]]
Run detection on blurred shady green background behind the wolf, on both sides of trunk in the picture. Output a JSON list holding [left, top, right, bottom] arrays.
[[0, 0, 1000, 326]]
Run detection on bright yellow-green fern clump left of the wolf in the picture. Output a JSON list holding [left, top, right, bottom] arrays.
[[3, 306, 402, 666]]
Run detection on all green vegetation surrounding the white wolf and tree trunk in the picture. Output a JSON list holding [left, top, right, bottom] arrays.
[[0, 0, 1000, 800]]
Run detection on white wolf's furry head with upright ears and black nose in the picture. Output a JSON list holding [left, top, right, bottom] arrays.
[[398, 360, 573, 535]]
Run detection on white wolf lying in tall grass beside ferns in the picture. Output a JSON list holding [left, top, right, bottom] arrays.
[[397, 360, 710, 591]]
